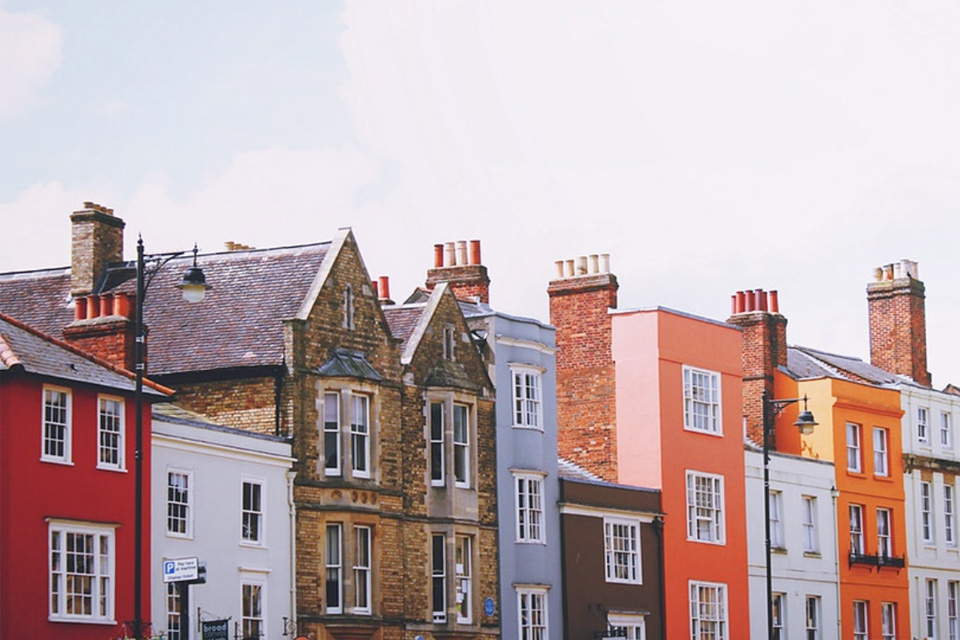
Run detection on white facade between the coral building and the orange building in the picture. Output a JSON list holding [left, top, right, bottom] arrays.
[[745, 445, 840, 640]]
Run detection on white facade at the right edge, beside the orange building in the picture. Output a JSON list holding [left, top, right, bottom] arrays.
[[899, 383, 960, 640]]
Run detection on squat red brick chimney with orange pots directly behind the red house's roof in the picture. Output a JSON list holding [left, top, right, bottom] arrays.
[[63, 293, 137, 371]]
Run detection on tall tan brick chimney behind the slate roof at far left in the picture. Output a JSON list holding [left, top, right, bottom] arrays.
[[70, 202, 125, 296]]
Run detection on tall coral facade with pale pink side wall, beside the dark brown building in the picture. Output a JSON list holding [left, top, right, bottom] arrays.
[[612, 309, 750, 640]]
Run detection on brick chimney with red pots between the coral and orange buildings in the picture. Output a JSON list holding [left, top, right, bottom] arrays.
[[727, 289, 787, 449]]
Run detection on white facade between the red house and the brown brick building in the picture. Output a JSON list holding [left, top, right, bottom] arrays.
[[150, 405, 296, 640]]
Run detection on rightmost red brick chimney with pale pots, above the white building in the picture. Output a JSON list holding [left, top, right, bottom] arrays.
[[867, 260, 932, 387]]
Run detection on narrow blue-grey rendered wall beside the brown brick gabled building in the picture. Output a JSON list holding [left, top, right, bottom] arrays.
[[468, 312, 563, 640]]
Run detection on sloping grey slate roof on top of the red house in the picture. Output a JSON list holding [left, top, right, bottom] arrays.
[[0, 313, 173, 397]]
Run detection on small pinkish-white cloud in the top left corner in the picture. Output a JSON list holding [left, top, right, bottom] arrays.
[[0, 8, 61, 118]]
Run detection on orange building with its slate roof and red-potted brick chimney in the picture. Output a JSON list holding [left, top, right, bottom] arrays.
[[729, 292, 911, 640]]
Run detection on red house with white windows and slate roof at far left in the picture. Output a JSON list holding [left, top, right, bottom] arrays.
[[0, 313, 168, 640]]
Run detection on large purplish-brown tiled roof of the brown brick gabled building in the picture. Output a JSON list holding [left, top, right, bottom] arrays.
[[0, 242, 331, 376]]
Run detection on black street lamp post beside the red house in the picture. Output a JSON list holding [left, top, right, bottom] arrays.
[[133, 237, 210, 640]]
